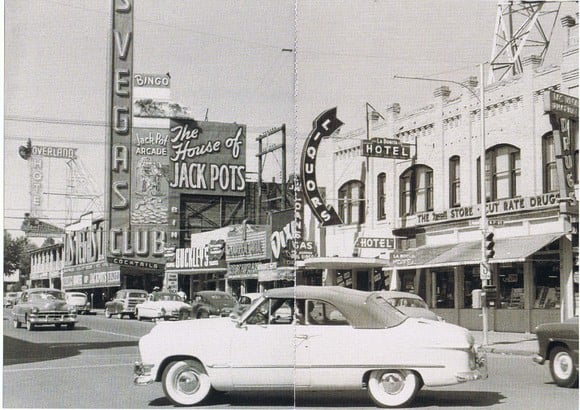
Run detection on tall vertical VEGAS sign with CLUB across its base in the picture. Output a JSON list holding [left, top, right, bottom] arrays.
[[106, 0, 165, 269]]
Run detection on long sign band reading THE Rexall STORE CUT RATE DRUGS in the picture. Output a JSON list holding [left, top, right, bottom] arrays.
[[416, 193, 560, 225]]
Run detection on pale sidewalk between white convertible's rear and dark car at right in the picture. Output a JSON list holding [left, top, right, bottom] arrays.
[[470, 330, 538, 356]]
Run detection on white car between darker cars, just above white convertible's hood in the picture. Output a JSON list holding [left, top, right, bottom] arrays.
[[135, 292, 191, 320]]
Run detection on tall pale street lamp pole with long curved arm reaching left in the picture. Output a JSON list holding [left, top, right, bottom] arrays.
[[393, 64, 491, 345]]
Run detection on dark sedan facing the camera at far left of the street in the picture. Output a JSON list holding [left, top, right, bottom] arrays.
[[12, 288, 77, 330]]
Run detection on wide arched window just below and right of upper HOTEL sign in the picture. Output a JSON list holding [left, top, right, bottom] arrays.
[[399, 165, 433, 216]]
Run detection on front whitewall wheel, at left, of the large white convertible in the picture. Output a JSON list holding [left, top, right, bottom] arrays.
[[162, 360, 211, 406]]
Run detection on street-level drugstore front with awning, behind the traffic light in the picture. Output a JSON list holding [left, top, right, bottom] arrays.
[[392, 233, 578, 332]]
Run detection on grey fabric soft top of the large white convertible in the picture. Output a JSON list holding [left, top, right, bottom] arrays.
[[264, 285, 406, 328]]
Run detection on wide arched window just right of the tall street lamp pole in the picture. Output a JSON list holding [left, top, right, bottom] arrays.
[[477, 145, 521, 202]]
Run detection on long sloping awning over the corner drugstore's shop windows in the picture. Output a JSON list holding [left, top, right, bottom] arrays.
[[396, 233, 562, 269]]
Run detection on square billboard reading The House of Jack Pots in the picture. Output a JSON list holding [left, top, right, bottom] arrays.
[[169, 119, 246, 196]]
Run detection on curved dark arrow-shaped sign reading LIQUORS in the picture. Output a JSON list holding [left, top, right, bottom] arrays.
[[300, 107, 343, 226]]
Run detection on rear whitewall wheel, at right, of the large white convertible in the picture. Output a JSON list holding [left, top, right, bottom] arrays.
[[368, 370, 421, 407]]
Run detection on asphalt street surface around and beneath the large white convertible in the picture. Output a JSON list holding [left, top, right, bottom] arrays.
[[2, 310, 578, 409]]
